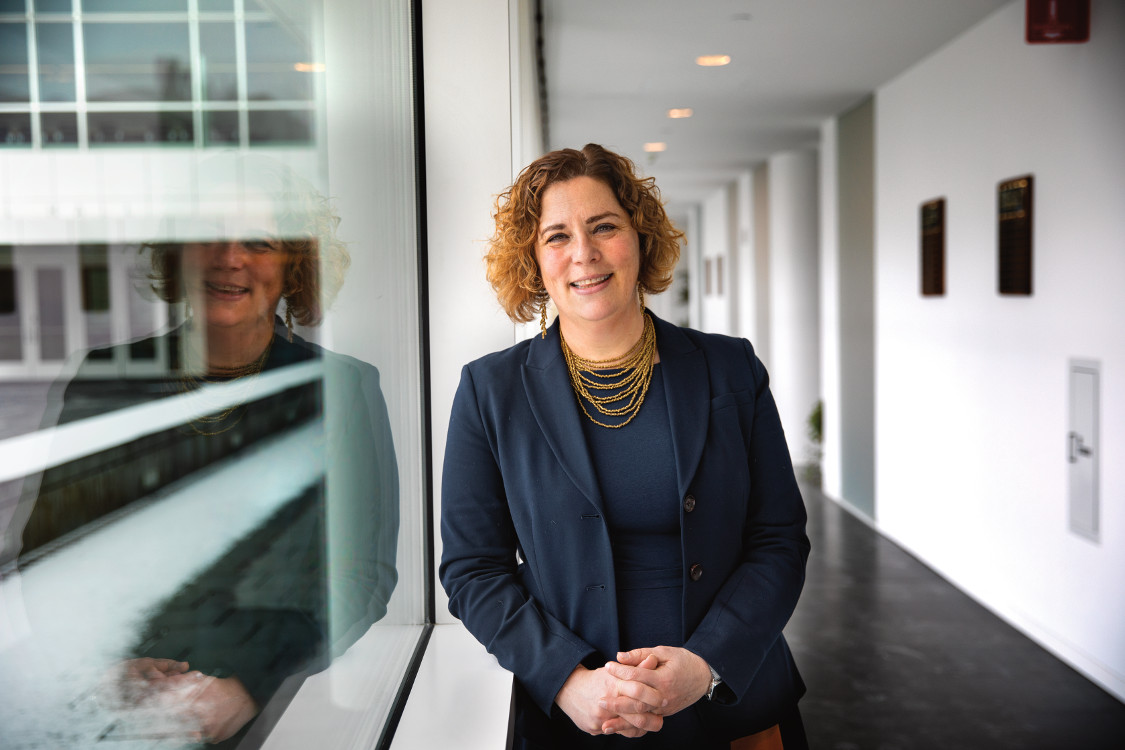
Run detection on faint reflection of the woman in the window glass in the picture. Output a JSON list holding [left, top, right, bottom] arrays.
[[17, 157, 398, 747]]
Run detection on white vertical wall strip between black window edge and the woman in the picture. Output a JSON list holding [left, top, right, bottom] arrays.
[[422, 0, 524, 623]]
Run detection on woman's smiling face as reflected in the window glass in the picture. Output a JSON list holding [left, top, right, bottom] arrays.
[[183, 203, 288, 329]]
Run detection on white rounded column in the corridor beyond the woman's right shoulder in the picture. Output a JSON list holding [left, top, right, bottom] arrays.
[[768, 150, 820, 463]]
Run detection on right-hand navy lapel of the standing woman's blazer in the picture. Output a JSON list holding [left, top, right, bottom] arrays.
[[649, 313, 711, 497]]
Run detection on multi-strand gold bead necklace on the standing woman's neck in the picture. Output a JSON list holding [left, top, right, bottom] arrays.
[[559, 315, 656, 430]]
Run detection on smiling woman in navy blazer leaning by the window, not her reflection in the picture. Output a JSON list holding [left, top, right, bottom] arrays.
[[440, 144, 809, 748]]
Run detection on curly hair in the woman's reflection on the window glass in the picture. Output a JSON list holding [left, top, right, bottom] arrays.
[[147, 155, 351, 326]]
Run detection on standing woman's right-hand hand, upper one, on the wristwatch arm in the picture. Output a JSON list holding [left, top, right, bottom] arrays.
[[605, 645, 711, 716]]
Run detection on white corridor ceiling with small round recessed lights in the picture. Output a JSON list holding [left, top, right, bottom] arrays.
[[542, 0, 1022, 205]]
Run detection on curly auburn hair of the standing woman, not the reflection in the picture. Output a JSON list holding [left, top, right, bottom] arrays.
[[485, 143, 684, 323]]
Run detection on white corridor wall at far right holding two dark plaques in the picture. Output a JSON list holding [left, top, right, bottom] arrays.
[[875, 0, 1125, 699]]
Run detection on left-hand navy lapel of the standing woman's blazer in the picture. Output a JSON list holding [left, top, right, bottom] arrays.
[[523, 320, 605, 515]]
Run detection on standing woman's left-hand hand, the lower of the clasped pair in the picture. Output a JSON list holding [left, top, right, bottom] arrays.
[[555, 657, 666, 738]]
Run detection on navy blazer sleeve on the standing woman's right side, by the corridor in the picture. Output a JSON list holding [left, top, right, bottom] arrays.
[[684, 341, 810, 704]]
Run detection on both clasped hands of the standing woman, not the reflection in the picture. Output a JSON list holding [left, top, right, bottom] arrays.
[[555, 645, 711, 738]]
